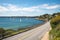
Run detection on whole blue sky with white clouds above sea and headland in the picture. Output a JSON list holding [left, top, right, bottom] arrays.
[[0, 0, 60, 16]]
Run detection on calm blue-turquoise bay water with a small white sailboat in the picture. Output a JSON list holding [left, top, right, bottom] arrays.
[[0, 17, 44, 29]]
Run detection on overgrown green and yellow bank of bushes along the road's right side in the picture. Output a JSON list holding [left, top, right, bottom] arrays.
[[49, 16, 60, 40]]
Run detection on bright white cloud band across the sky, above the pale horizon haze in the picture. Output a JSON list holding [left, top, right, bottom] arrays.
[[0, 4, 60, 12]]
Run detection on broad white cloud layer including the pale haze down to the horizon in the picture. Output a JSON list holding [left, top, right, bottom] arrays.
[[0, 4, 60, 15]]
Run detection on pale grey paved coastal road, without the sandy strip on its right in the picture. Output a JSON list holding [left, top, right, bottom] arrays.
[[3, 22, 50, 40]]
